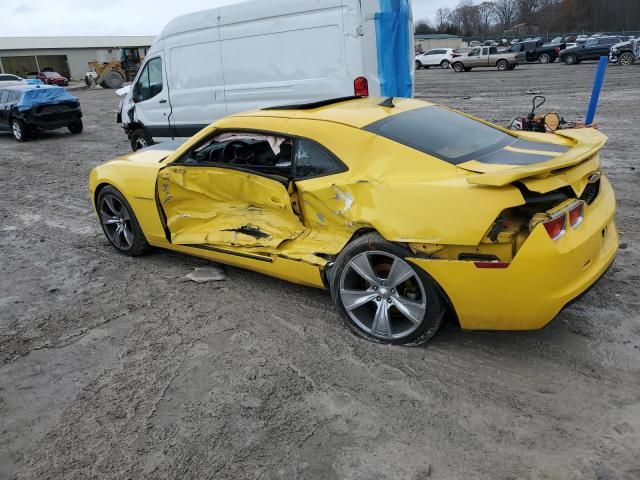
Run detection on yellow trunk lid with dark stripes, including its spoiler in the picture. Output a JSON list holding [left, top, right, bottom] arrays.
[[458, 128, 607, 187]]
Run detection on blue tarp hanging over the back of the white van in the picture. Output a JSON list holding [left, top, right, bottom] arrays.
[[375, 0, 414, 98]]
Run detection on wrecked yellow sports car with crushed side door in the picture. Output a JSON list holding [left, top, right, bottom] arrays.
[[90, 97, 618, 344]]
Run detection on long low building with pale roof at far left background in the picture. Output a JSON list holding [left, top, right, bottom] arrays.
[[0, 36, 154, 80]]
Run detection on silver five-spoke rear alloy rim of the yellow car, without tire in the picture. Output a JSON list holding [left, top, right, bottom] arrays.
[[340, 251, 427, 340]]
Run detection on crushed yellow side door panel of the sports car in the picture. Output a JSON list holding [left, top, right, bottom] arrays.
[[158, 166, 304, 248]]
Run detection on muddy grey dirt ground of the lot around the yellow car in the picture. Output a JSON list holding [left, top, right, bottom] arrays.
[[0, 63, 640, 480]]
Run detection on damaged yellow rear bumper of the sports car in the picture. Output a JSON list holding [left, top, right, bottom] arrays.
[[411, 177, 618, 330]]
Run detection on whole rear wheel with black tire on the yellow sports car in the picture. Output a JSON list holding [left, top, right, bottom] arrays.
[[331, 233, 446, 345]]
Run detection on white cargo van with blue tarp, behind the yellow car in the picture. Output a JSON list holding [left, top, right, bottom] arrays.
[[118, 0, 414, 150]]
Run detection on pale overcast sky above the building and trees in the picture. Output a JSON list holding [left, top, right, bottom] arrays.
[[0, 0, 450, 37]]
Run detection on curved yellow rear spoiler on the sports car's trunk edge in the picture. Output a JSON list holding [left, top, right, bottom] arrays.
[[467, 128, 607, 187]]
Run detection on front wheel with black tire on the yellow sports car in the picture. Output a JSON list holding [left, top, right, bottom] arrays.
[[96, 185, 150, 257]]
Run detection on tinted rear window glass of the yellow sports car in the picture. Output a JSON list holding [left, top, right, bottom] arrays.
[[364, 107, 516, 165]]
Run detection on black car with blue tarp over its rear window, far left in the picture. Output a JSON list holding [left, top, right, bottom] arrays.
[[0, 83, 82, 142]]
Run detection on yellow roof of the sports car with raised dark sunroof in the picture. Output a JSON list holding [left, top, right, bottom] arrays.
[[232, 97, 433, 128]]
